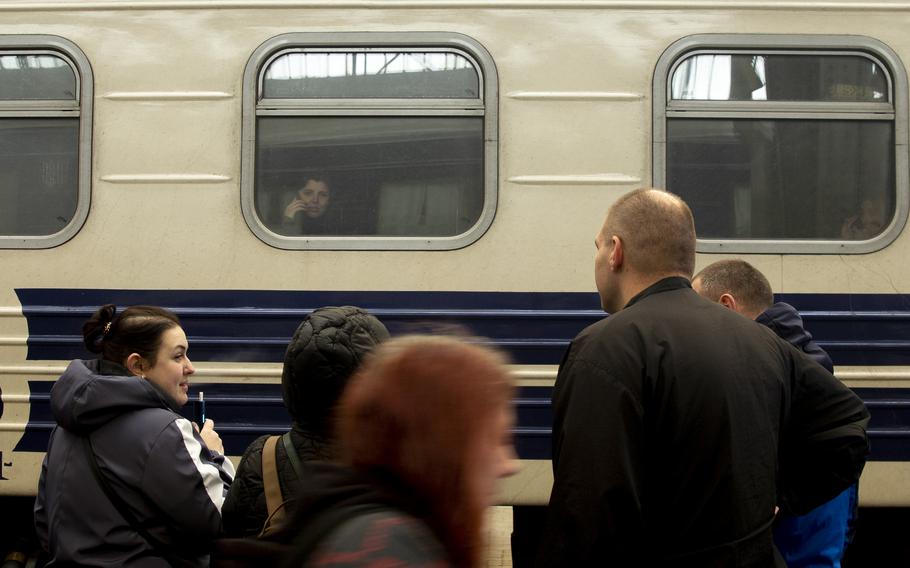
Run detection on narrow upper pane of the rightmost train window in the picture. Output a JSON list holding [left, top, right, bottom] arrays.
[[670, 54, 889, 102]]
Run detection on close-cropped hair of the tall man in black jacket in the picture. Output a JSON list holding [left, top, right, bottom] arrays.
[[604, 188, 695, 277]]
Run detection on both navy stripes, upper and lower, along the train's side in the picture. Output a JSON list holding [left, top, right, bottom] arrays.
[[16, 289, 910, 461]]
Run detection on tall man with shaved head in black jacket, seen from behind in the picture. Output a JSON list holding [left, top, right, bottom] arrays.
[[538, 189, 869, 568]]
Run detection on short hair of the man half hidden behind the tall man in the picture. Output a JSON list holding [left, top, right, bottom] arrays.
[[695, 259, 774, 313]]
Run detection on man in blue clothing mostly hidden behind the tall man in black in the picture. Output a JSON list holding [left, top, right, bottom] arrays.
[[692, 259, 858, 568]]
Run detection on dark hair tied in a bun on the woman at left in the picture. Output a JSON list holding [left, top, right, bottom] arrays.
[[82, 304, 180, 365]]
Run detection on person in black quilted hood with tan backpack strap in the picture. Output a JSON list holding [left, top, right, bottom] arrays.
[[223, 306, 389, 537]]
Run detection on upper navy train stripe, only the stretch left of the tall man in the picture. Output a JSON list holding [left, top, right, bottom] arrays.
[[16, 289, 604, 364]]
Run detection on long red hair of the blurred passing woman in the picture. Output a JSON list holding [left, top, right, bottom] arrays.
[[338, 336, 512, 566]]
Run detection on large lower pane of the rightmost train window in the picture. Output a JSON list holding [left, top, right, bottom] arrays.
[[667, 119, 895, 240]]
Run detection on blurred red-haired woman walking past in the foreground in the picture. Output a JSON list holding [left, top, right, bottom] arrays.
[[282, 336, 517, 567]]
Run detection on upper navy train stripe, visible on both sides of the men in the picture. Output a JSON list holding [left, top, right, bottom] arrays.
[[16, 289, 910, 365]]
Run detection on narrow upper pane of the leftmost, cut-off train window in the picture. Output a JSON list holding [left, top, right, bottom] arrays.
[[0, 53, 77, 101]]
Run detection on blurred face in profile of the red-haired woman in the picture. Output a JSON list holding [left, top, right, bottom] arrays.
[[468, 404, 518, 507]]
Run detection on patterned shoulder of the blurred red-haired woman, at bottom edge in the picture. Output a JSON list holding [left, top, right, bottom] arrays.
[[314, 509, 449, 567]]
